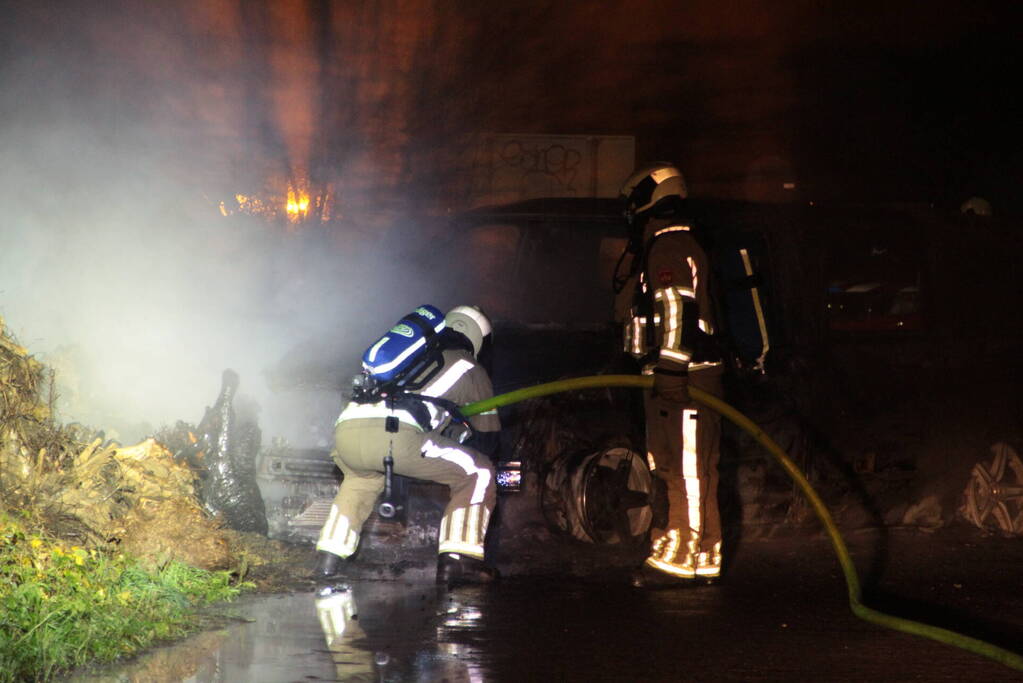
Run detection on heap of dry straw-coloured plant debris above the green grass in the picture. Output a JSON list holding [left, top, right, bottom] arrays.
[[0, 319, 280, 570]]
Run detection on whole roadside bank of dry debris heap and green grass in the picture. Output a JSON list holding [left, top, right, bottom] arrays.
[[0, 318, 317, 682]]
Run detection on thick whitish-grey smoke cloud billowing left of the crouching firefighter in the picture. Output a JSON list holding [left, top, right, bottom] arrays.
[[0, 1, 451, 446]]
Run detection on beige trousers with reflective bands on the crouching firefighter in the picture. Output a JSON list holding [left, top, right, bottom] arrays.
[[316, 418, 497, 559]]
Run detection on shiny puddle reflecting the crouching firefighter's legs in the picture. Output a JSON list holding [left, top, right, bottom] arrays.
[[70, 581, 486, 683]]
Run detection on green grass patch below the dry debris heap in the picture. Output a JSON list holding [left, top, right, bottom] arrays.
[[0, 512, 244, 683]]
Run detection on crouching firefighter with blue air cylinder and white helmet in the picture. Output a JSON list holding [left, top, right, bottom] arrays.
[[315, 306, 500, 586]]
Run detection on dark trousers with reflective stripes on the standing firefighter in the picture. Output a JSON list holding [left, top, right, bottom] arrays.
[[644, 366, 722, 578]]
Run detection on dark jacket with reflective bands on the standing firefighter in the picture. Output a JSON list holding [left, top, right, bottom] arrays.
[[615, 219, 721, 374]]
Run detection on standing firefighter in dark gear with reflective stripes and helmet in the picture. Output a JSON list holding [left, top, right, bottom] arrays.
[[615, 163, 722, 586]]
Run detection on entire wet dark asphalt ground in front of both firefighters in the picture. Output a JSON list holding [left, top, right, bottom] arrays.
[[75, 528, 1023, 683]]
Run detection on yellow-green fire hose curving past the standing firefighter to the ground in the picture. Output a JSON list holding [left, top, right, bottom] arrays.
[[461, 374, 1023, 671]]
